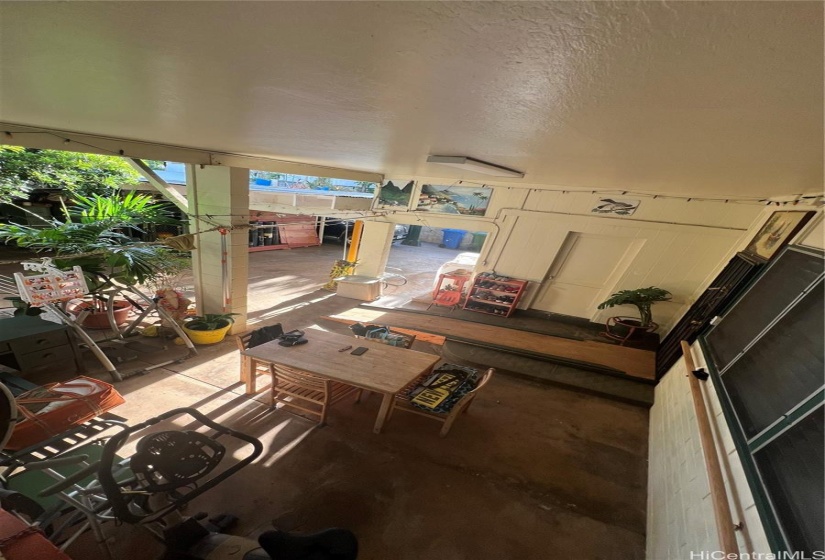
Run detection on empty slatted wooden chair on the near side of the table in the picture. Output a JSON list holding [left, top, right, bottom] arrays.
[[270, 365, 359, 426]]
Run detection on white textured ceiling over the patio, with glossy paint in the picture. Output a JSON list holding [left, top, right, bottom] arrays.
[[0, 2, 823, 196]]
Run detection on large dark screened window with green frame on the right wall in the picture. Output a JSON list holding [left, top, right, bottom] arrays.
[[702, 247, 825, 554]]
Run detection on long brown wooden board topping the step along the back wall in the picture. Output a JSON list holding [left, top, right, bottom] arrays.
[[330, 308, 656, 380]]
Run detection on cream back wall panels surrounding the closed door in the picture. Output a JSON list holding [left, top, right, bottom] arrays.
[[484, 189, 764, 334]]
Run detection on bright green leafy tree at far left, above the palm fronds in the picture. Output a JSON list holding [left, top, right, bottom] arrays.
[[0, 146, 140, 203]]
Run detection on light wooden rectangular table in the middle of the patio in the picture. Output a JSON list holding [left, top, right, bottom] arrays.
[[242, 329, 441, 434]]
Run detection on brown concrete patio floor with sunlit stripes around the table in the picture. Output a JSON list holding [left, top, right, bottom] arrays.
[[3, 242, 648, 560]]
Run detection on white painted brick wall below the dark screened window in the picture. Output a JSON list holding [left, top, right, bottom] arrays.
[[647, 344, 770, 560]]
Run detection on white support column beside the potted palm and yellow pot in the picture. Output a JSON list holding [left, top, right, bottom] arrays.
[[186, 165, 249, 333]]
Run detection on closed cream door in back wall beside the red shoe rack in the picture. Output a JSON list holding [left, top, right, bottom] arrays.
[[532, 231, 644, 319]]
